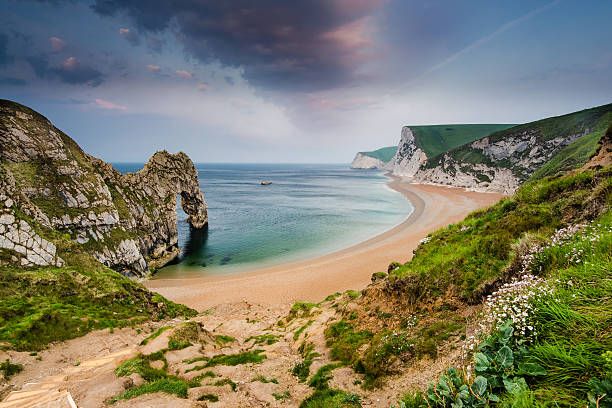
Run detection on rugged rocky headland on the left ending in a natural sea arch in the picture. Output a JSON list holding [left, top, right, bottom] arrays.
[[0, 100, 208, 277]]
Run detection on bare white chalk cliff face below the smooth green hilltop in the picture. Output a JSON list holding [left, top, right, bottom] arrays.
[[389, 105, 612, 194]]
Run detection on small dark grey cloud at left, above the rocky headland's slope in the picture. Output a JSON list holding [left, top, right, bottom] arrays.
[[26, 55, 104, 87]]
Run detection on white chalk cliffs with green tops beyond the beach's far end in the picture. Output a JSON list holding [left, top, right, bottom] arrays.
[[355, 104, 612, 194]]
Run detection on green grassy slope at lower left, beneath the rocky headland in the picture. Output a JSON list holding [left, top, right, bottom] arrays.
[[0, 264, 196, 351]]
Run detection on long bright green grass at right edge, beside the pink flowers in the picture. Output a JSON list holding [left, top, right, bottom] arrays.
[[530, 217, 612, 407]]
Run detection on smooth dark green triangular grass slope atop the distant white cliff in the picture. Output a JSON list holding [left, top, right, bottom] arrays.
[[409, 124, 514, 157]]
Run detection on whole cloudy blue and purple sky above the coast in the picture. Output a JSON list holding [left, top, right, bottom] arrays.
[[0, 0, 612, 163]]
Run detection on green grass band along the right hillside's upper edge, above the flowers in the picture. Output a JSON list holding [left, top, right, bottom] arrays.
[[388, 169, 612, 303]]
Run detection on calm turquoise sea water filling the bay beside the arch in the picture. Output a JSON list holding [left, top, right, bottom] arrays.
[[114, 163, 412, 278]]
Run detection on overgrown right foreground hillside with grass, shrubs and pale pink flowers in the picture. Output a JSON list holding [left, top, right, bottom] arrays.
[[326, 146, 612, 408]]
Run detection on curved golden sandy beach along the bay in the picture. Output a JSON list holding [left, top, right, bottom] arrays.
[[144, 177, 503, 311]]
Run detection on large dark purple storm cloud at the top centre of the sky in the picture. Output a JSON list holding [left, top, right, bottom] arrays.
[[93, 0, 384, 89]]
